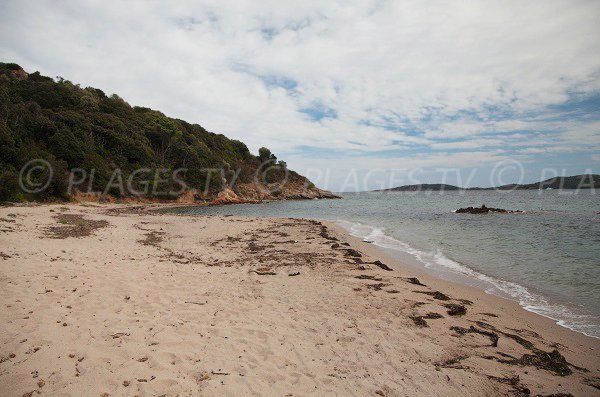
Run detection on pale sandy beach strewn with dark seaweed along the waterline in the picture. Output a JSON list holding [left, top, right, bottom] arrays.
[[0, 203, 600, 396]]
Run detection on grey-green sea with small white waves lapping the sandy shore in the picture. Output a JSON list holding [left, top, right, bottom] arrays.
[[170, 190, 600, 338]]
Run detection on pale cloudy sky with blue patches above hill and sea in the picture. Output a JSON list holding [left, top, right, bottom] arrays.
[[0, 0, 600, 191]]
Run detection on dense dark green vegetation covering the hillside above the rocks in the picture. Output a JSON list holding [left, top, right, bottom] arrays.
[[0, 63, 290, 201]]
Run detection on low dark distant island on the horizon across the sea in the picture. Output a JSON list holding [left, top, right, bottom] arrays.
[[375, 174, 600, 192]]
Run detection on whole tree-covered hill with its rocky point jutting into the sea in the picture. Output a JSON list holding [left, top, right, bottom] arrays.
[[0, 63, 336, 203]]
